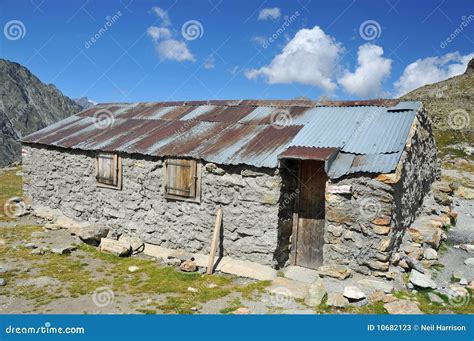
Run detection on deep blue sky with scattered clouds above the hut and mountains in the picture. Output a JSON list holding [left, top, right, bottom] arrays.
[[0, 0, 474, 102]]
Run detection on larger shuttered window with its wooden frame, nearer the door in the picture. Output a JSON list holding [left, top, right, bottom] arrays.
[[165, 159, 201, 202]]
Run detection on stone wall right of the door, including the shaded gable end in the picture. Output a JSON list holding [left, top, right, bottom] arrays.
[[323, 110, 438, 274]]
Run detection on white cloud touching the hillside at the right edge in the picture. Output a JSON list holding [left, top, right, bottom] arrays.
[[395, 52, 474, 96]]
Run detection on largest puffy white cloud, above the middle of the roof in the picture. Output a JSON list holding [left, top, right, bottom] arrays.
[[245, 26, 343, 92]]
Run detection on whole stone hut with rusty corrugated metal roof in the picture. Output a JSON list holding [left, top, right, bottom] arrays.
[[23, 100, 438, 274]]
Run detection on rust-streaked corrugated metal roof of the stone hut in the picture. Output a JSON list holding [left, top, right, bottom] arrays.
[[23, 100, 420, 177]]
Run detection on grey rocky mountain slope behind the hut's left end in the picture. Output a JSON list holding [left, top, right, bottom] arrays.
[[0, 59, 82, 167]]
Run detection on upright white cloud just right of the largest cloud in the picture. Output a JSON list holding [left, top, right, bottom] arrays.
[[338, 43, 392, 97]]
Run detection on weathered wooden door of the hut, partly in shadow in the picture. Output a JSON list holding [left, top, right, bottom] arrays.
[[294, 160, 327, 269]]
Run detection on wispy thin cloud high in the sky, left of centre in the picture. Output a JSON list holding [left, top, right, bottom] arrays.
[[147, 7, 196, 62]]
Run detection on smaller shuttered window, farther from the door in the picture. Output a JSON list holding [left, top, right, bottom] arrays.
[[96, 153, 122, 189]]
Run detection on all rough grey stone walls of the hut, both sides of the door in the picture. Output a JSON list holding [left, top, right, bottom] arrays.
[[23, 109, 438, 274]]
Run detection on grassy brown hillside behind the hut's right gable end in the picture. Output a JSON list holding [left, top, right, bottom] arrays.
[[401, 59, 474, 156]]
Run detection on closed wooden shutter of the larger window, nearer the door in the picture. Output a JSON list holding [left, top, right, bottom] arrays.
[[166, 159, 197, 198]]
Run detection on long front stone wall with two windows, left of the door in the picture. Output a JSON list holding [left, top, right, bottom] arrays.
[[23, 146, 282, 266]]
